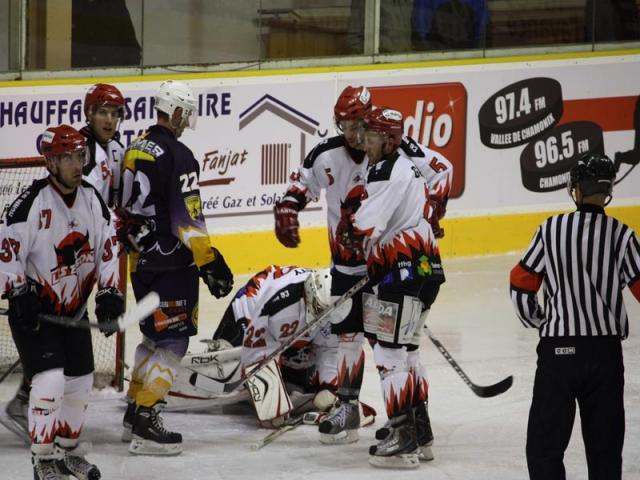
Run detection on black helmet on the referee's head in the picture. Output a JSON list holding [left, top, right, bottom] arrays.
[[567, 153, 616, 203]]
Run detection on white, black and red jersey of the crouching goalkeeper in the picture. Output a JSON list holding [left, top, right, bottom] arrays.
[[232, 265, 337, 383]]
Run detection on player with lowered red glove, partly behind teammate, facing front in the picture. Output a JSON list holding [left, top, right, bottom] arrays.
[[274, 86, 372, 444]]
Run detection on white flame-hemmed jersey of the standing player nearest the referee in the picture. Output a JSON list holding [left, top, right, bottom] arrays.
[[351, 146, 444, 282]]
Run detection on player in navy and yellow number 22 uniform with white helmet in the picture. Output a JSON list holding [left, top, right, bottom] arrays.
[[122, 80, 233, 455]]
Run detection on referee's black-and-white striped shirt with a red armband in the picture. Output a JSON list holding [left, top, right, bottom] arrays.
[[511, 204, 640, 338]]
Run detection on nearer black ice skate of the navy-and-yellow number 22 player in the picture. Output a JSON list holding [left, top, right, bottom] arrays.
[[129, 402, 182, 455]]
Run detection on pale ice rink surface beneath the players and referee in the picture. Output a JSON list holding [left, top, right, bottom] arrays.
[[0, 255, 640, 480]]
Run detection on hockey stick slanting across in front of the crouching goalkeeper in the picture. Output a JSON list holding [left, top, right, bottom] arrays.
[[189, 275, 369, 393]]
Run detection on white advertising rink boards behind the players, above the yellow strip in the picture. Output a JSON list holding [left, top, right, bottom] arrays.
[[0, 55, 640, 233]]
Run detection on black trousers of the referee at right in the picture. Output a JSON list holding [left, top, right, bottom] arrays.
[[527, 337, 625, 480]]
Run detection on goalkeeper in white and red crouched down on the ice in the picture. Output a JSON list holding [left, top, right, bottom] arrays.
[[169, 265, 375, 427]]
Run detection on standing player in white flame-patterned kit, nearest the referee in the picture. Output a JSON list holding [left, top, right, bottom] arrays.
[[338, 108, 444, 468]]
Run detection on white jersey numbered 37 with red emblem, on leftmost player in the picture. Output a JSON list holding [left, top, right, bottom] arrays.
[[0, 179, 119, 316]]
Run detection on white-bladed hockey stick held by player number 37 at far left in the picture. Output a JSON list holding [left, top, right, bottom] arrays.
[[38, 292, 160, 332]]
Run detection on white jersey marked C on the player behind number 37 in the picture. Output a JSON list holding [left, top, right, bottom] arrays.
[[80, 127, 124, 207]]
